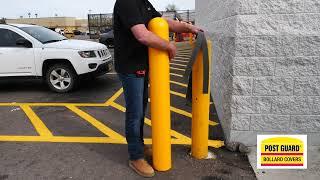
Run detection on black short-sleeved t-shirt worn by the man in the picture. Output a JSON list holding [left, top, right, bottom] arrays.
[[113, 0, 161, 74]]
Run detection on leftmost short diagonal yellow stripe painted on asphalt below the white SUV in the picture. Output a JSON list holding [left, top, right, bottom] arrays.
[[20, 105, 52, 137]]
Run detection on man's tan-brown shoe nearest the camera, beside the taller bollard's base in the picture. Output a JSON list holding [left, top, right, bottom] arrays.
[[129, 159, 155, 177]]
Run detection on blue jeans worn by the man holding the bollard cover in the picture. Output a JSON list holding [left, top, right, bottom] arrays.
[[119, 74, 148, 160]]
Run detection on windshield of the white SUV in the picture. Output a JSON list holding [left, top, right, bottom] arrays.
[[20, 26, 67, 44]]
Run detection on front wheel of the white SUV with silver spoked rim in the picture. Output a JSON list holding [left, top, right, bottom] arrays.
[[46, 64, 78, 93]]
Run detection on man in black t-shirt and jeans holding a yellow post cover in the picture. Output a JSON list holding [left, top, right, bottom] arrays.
[[113, 0, 200, 177]]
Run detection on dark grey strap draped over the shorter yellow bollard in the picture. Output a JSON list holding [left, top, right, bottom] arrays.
[[184, 32, 210, 98]]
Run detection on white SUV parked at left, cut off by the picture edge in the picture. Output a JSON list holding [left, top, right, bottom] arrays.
[[0, 24, 113, 93]]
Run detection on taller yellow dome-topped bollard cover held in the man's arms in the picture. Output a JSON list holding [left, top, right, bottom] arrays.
[[149, 18, 171, 171]]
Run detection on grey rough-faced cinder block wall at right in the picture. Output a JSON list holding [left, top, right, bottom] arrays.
[[196, 0, 320, 145]]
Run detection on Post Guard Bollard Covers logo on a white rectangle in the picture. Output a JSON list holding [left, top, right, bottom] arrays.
[[257, 135, 307, 169]]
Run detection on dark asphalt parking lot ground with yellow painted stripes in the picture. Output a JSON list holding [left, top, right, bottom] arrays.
[[0, 44, 255, 180]]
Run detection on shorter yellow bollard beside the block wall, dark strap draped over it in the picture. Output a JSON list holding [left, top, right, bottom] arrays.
[[191, 42, 211, 159]]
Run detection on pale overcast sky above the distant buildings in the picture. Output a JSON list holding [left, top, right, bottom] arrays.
[[0, 0, 195, 18]]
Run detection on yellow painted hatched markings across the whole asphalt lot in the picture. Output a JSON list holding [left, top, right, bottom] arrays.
[[0, 41, 224, 148]]
